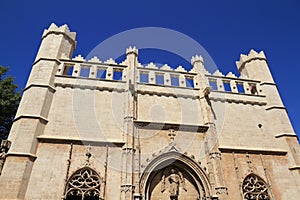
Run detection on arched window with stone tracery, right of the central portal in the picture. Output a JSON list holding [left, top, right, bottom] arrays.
[[242, 174, 270, 200]]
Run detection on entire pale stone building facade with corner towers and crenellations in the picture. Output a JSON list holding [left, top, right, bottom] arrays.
[[0, 24, 300, 200]]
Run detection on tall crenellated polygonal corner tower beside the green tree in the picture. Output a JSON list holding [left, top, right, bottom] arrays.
[[0, 24, 76, 199]]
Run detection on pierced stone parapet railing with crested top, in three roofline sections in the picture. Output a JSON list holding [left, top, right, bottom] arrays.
[[56, 55, 263, 96]]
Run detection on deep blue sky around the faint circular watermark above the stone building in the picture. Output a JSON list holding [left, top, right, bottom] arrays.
[[0, 0, 300, 138]]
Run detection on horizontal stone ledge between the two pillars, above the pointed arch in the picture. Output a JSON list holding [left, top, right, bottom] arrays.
[[134, 120, 208, 133]]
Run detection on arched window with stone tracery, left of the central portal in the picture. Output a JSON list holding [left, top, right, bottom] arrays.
[[65, 167, 101, 200]]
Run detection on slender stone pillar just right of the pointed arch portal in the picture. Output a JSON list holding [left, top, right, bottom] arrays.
[[191, 56, 228, 200]]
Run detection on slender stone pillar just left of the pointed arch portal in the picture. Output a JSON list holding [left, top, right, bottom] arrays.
[[121, 47, 139, 200]]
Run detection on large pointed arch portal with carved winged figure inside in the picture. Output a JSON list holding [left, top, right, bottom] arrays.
[[140, 151, 211, 200]]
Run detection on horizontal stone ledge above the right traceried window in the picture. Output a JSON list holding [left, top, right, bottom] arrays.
[[219, 147, 287, 156]]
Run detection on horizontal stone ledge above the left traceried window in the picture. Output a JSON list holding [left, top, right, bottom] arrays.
[[37, 135, 125, 147]]
